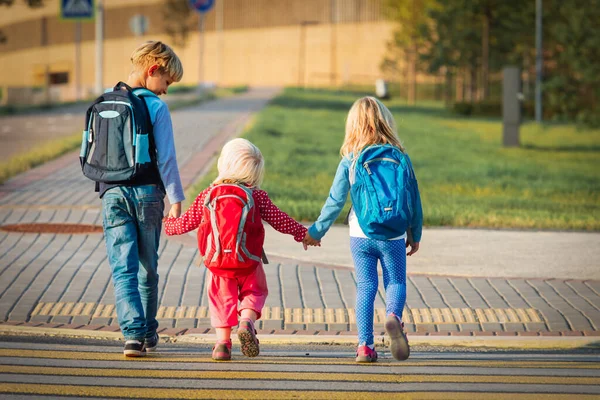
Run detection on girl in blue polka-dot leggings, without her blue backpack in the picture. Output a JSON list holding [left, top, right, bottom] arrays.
[[304, 97, 423, 362]]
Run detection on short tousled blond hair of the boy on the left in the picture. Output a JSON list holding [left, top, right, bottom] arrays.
[[131, 40, 183, 82]]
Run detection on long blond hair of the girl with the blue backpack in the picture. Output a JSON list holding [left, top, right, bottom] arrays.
[[340, 96, 406, 157]]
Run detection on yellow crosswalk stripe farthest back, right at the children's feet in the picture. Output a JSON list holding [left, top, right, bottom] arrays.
[[0, 349, 600, 369]]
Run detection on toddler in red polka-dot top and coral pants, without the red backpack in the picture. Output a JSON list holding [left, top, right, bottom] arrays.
[[164, 138, 306, 360]]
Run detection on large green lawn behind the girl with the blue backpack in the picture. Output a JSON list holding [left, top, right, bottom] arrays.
[[188, 89, 600, 231]]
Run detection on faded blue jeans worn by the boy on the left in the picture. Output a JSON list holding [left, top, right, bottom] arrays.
[[102, 185, 165, 341]]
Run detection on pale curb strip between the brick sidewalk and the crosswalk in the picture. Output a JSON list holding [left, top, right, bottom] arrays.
[[0, 325, 600, 350]]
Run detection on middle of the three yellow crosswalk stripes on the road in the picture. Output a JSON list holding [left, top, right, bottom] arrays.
[[0, 365, 600, 386]]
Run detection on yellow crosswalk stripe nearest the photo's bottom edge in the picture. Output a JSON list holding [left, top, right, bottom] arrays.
[[0, 383, 598, 400]]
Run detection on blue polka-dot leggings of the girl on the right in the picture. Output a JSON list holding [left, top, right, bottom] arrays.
[[350, 237, 406, 345]]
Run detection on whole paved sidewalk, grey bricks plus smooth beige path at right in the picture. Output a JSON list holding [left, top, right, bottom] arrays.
[[0, 89, 600, 342]]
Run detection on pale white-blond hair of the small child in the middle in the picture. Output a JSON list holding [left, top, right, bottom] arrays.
[[213, 138, 265, 188]]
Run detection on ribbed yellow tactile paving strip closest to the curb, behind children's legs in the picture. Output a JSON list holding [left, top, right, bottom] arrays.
[[31, 302, 542, 324]]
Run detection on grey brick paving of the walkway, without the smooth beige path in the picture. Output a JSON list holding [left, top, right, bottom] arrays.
[[0, 90, 600, 337]]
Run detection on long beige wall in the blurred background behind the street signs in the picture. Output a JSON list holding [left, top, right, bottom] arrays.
[[0, 0, 392, 100]]
